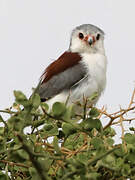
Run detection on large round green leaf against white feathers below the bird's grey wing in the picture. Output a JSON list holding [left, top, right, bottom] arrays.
[[52, 102, 66, 116]]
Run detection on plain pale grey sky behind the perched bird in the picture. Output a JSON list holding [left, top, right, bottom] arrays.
[[0, 0, 135, 140]]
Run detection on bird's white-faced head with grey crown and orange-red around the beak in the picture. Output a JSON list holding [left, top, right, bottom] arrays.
[[69, 24, 104, 54]]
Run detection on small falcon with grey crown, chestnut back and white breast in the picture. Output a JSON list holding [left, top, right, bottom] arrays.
[[38, 24, 107, 108]]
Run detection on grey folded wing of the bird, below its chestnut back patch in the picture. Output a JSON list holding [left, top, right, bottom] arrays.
[[39, 63, 87, 99]]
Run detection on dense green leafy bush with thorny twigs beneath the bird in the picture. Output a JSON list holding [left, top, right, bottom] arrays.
[[0, 91, 135, 180]]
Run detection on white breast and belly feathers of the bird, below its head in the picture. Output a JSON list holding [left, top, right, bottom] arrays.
[[71, 53, 107, 101]]
